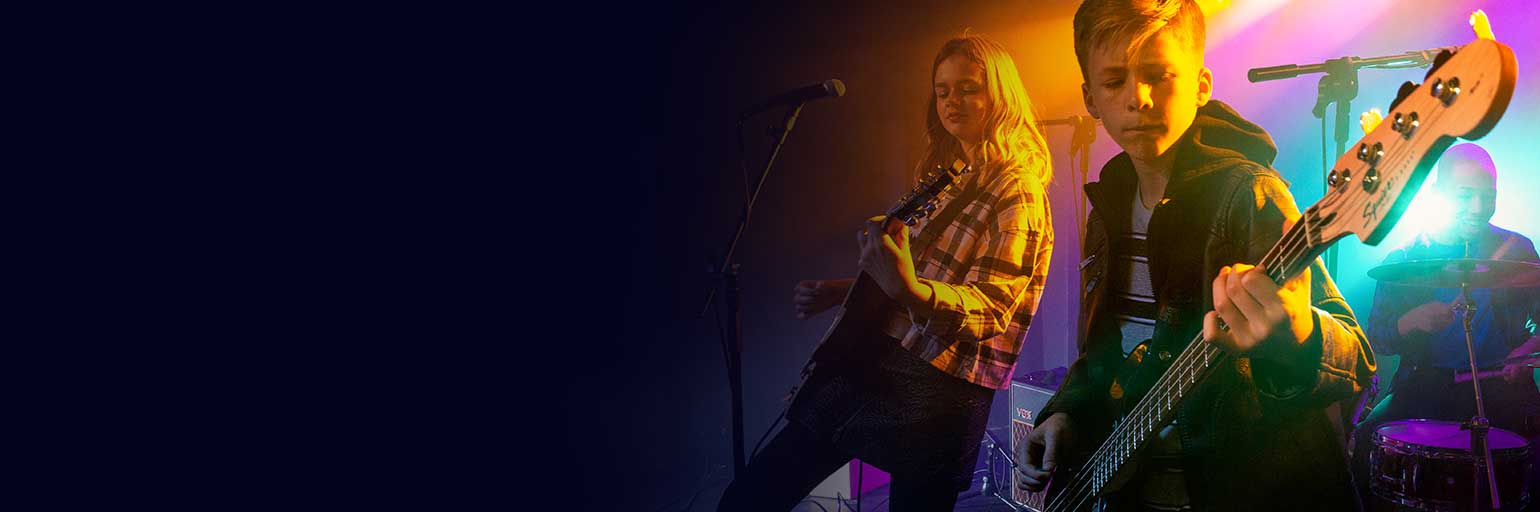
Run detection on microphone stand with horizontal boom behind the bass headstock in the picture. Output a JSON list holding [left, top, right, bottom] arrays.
[[1246, 46, 1458, 275]]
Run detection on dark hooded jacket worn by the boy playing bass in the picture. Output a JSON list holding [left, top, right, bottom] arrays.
[[1038, 100, 1374, 510]]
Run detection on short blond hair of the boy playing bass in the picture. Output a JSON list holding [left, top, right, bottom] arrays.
[[1075, 0, 1207, 80]]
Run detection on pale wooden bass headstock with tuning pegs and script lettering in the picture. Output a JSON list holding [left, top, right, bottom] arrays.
[[1303, 39, 1518, 250]]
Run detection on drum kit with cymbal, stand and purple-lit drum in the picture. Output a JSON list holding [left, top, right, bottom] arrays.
[[1369, 258, 1540, 510]]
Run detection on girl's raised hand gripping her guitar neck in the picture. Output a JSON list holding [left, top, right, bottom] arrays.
[[856, 216, 930, 307]]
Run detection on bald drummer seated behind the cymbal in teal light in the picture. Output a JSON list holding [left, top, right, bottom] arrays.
[[1354, 143, 1540, 503]]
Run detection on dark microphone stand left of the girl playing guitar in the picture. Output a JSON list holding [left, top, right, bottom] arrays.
[[698, 102, 807, 477]]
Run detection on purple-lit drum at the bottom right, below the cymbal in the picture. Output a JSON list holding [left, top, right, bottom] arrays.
[[1369, 419, 1531, 510]]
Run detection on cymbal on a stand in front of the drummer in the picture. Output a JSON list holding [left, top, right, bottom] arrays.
[[1369, 258, 1540, 288]]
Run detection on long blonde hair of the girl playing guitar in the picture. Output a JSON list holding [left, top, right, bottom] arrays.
[[915, 32, 1053, 187]]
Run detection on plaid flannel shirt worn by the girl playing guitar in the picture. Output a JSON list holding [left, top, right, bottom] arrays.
[[902, 164, 1053, 389]]
